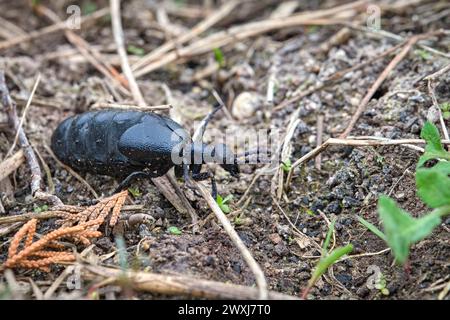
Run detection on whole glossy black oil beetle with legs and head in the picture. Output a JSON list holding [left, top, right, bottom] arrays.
[[51, 107, 253, 198]]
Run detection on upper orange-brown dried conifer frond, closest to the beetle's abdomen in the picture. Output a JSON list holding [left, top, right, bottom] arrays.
[[58, 190, 128, 230]]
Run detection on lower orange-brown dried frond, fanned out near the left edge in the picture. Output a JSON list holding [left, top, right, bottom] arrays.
[[4, 218, 103, 271]]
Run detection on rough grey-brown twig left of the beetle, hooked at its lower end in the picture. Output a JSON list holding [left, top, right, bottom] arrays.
[[0, 70, 62, 205]]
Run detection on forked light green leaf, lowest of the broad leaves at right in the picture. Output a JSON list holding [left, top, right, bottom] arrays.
[[378, 196, 441, 264]]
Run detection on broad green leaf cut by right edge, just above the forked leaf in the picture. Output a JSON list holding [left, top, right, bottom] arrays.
[[416, 161, 450, 208]]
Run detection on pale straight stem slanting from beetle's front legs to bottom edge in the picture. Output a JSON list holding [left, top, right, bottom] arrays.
[[196, 182, 268, 299]]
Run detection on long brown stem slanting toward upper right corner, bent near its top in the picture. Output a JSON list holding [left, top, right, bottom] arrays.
[[340, 30, 443, 138]]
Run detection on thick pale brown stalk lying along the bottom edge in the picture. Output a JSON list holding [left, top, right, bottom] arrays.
[[81, 265, 298, 300]]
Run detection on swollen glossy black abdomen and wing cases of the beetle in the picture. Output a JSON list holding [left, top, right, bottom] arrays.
[[52, 110, 189, 177]]
